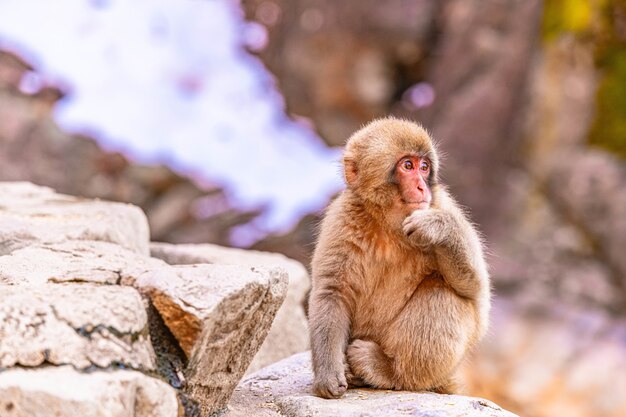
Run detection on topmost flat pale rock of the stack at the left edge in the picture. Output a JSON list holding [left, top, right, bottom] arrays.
[[0, 182, 149, 255]]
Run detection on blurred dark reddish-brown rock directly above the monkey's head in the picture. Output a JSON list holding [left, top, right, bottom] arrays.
[[243, 0, 439, 145]]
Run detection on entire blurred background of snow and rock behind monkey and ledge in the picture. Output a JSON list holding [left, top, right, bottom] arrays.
[[0, 0, 626, 417]]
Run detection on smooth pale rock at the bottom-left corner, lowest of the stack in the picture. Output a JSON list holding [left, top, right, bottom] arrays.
[[0, 366, 179, 417]]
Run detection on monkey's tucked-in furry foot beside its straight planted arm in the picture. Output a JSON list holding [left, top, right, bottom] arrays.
[[346, 339, 395, 389]]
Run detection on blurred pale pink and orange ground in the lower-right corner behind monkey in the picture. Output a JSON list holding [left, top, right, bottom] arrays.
[[464, 298, 626, 417]]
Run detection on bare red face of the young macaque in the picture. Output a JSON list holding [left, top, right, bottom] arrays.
[[396, 156, 432, 210]]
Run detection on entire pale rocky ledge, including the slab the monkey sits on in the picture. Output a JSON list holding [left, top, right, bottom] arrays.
[[0, 183, 511, 417]]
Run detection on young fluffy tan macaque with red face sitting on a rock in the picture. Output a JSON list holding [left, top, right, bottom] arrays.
[[309, 118, 490, 398]]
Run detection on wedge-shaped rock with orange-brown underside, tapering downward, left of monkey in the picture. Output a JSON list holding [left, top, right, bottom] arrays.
[[134, 265, 287, 415]]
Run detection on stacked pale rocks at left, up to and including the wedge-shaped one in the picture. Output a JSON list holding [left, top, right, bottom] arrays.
[[0, 183, 288, 417]]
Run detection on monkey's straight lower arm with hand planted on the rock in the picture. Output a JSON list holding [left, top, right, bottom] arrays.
[[309, 260, 350, 398]]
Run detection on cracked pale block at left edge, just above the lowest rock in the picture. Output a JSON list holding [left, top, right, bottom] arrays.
[[0, 284, 154, 370]]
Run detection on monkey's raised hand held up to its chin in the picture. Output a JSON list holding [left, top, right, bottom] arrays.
[[402, 209, 460, 250]]
